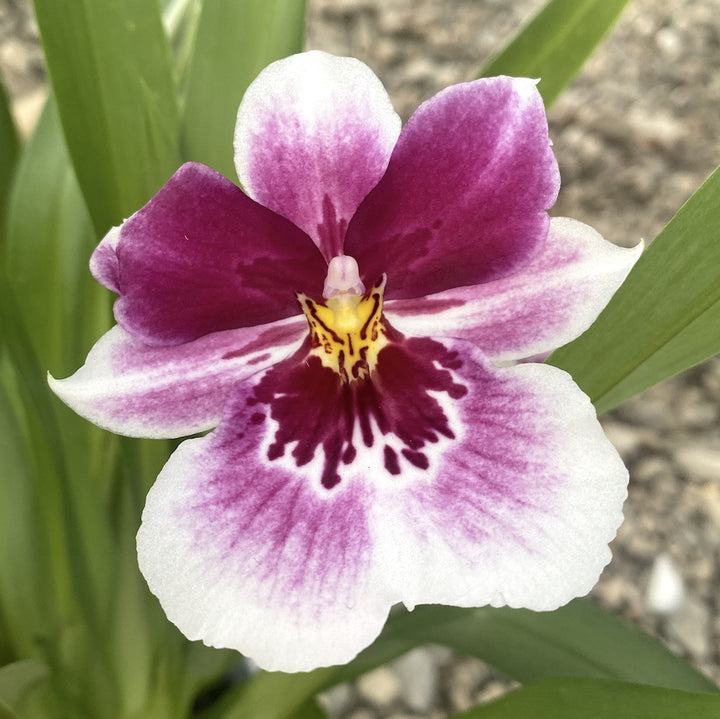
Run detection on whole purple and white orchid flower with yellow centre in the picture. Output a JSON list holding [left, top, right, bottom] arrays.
[[50, 52, 640, 671]]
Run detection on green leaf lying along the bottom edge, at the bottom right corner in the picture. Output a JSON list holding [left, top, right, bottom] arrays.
[[454, 679, 720, 719]]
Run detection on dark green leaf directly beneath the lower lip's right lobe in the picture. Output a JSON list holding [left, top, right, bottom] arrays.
[[390, 599, 718, 692]]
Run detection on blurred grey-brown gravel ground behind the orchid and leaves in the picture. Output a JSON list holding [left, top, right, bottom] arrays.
[[0, 0, 720, 719]]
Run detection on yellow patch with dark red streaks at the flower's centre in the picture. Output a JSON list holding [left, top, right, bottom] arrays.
[[298, 277, 388, 382]]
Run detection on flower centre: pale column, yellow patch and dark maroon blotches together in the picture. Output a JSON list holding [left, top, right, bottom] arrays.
[[262, 256, 467, 490]]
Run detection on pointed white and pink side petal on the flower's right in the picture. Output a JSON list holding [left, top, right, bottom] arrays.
[[385, 217, 643, 361]]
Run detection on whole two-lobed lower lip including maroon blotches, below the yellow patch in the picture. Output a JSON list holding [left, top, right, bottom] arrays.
[[138, 332, 627, 671]]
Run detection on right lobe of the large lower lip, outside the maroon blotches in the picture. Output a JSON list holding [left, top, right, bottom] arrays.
[[371, 341, 628, 610]]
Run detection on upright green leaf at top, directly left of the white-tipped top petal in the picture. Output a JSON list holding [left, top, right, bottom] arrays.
[[182, 0, 305, 178]]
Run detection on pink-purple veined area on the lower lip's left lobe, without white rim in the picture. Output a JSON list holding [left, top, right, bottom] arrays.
[[178, 402, 372, 612]]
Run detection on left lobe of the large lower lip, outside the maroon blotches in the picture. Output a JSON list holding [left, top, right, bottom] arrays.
[[137, 380, 392, 671]]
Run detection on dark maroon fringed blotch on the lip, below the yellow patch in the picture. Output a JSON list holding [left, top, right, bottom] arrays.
[[248, 330, 468, 489]]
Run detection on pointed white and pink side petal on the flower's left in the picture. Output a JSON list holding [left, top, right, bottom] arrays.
[[49, 318, 307, 437]]
